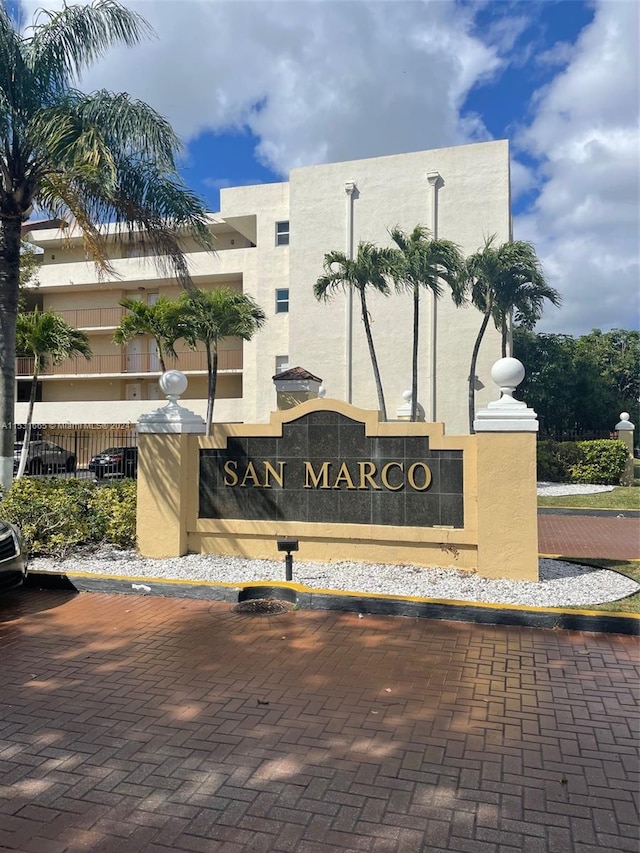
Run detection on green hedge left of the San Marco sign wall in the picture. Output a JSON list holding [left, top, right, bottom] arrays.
[[0, 477, 136, 557]]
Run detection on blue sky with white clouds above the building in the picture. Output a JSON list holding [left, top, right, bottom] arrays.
[[20, 0, 640, 334]]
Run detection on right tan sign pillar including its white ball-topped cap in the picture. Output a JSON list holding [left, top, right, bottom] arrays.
[[473, 358, 539, 581]]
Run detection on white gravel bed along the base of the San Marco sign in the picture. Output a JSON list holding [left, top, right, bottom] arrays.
[[30, 548, 640, 607]]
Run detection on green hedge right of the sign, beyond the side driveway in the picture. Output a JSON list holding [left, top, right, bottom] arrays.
[[538, 439, 628, 486]]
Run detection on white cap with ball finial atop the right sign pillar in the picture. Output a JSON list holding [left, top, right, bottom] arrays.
[[473, 358, 538, 432]]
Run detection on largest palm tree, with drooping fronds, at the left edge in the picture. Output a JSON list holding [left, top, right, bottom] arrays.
[[0, 0, 211, 486]]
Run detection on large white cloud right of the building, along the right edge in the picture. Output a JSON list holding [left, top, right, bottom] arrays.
[[515, 0, 640, 334]]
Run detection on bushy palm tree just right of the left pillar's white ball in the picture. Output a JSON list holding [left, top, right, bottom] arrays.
[[176, 287, 267, 435]]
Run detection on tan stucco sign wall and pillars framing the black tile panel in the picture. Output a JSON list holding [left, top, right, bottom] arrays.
[[138, 400, 538, 580]]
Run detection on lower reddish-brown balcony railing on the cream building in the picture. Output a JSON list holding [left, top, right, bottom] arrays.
[[16, 349, 242, 379]]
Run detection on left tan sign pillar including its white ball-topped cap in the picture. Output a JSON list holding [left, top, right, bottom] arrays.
[[136, 370, 205, 558]]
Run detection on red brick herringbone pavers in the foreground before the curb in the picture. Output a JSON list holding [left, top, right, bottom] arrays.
[[0, 589, 639, 853]]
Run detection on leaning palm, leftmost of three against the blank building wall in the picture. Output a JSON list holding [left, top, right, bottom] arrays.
[[313, 241, 395, 421]]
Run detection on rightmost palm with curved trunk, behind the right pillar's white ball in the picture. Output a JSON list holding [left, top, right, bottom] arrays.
[[464, 235, 561, 433]]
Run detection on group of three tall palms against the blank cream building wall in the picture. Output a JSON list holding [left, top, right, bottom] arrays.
[[314, 225, 561, 432]]
